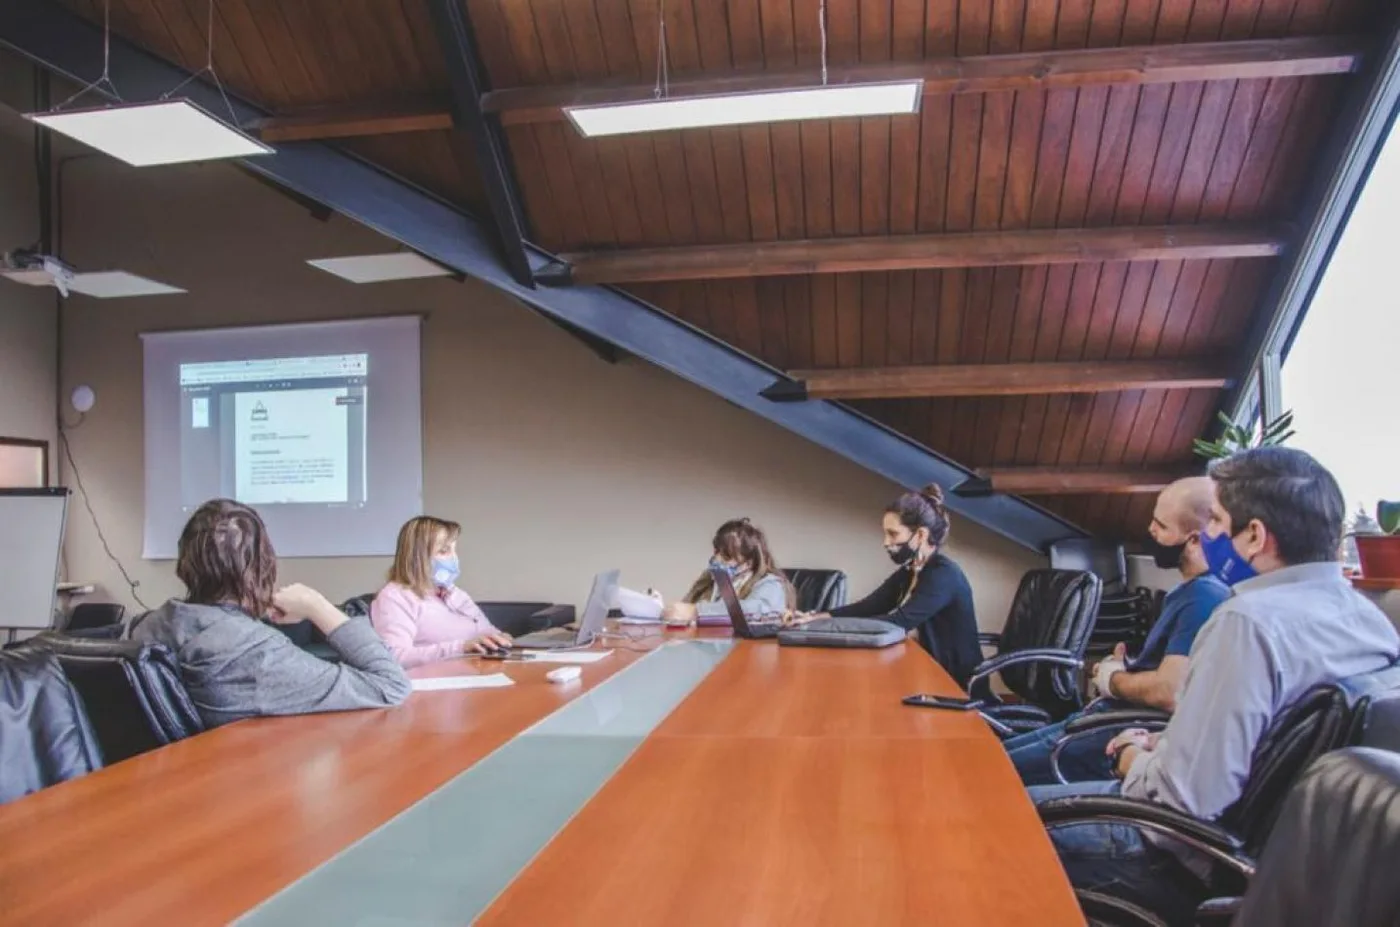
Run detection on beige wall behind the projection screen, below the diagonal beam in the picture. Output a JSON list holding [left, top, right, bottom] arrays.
[[54, 160, 1037, 627]]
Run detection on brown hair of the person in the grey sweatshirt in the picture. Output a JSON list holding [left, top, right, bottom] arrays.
[[175, 499, 277, 618]]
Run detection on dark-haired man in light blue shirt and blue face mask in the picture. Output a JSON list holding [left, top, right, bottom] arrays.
[[1030, 448, 1400, 923]]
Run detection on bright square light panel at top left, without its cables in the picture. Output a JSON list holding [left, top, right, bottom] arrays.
[[28, 99, 272, 167]]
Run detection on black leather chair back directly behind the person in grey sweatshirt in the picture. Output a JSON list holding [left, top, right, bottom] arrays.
[[21, 633, 204, 765]]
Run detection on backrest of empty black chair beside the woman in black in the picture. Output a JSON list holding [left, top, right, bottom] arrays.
[[997, 570, 1103, 718]]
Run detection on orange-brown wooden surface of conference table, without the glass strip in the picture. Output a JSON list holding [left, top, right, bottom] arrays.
[[0, 633, 1084, 927]]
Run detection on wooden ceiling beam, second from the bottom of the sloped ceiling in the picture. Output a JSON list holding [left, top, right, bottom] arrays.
[[764, 358, 1231, 400]]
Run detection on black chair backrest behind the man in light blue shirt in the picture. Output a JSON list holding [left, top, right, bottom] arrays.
[[1221, 664, 1400, 854]]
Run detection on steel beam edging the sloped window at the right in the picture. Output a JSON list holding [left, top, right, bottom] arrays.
[[1212, 11, 1400, 437]]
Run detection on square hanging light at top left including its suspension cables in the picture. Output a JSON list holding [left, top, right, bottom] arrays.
[[27, 0, 273, 167]]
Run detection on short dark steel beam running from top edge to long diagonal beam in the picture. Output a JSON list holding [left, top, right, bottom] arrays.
[[426, 0, 535, 288]]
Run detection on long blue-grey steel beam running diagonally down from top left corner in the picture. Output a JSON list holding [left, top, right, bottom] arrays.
[[0, 0, 1084, 552]]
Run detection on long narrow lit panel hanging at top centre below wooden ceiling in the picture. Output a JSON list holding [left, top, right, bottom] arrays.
[[564, 80, 924, 137]]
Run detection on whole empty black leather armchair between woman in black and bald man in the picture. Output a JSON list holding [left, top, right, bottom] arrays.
[[967, 570, 1103, 737]]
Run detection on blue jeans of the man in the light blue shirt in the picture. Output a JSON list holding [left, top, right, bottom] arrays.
[[1029, 781, 1208, 926]]
